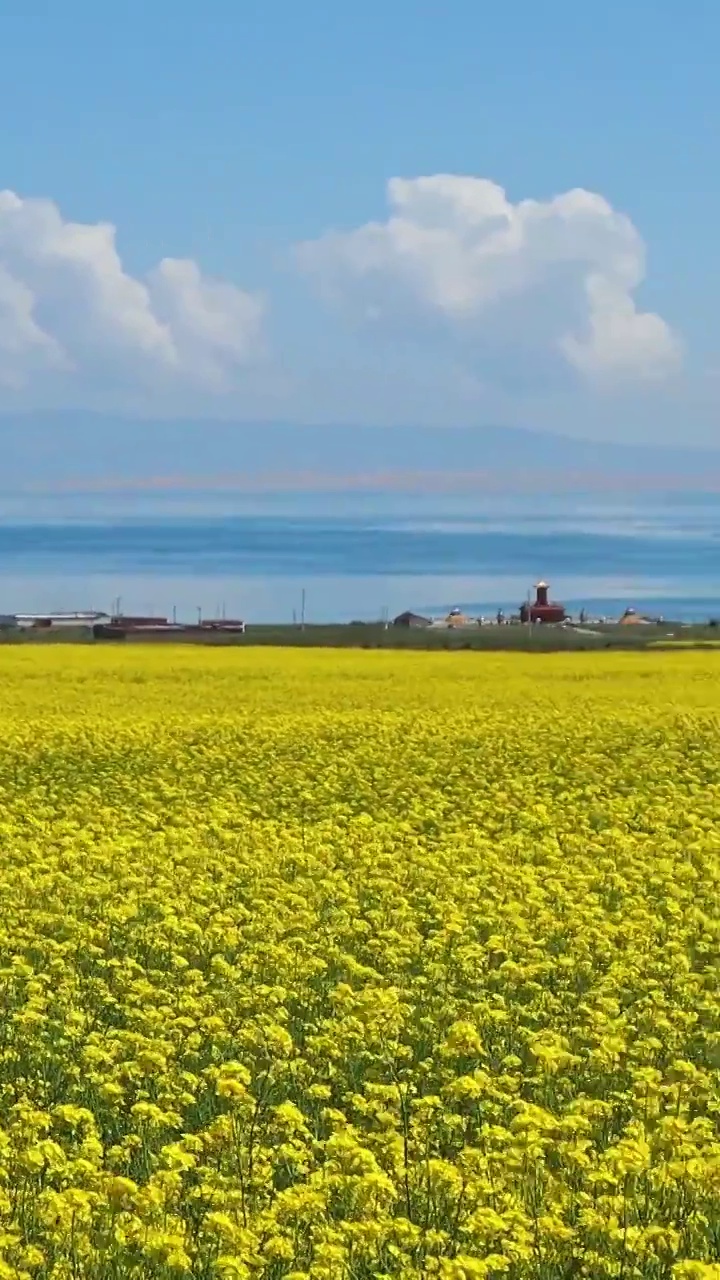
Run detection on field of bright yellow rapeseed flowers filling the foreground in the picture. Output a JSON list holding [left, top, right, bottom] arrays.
[[0, 646, 720, 1280]]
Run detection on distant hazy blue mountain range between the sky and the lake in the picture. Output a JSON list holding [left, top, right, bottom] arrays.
[[0, 412, 720, 493]]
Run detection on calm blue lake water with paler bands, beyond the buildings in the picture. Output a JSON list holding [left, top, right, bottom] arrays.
[[0, 494, 720, 622]]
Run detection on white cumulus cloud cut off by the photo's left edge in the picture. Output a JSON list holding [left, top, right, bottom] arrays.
[[0, 191, 264, 389]]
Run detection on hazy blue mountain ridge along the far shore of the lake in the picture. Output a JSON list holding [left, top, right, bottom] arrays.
[[0, 412, 720, 486]]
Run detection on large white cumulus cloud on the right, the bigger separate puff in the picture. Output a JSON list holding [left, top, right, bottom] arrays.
[[296, 174, 682, 380]]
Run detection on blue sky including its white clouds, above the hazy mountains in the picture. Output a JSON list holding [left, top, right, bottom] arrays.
[[0, 0, 720, 458]]
